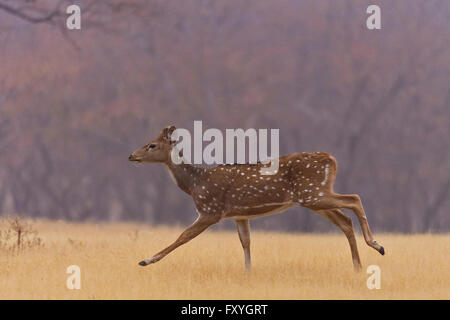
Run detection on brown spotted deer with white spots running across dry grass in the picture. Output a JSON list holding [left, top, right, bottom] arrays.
[[129, 126, 384, 271]]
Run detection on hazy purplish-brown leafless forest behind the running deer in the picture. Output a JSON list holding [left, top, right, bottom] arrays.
[[0, 0, 450, 232]]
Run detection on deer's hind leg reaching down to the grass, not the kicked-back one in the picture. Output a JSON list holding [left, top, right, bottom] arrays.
[[315, 209, 361, 272]]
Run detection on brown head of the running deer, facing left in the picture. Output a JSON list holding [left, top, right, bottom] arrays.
[[128, 126, 176, 163]]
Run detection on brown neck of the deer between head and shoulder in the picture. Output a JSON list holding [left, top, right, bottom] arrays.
[[164, 161, 204, 194]]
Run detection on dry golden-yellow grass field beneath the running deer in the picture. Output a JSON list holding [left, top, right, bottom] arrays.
[[0, 221, 450, 299]]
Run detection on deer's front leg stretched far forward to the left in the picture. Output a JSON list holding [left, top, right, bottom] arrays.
[[139, 215, 220, 266]]
